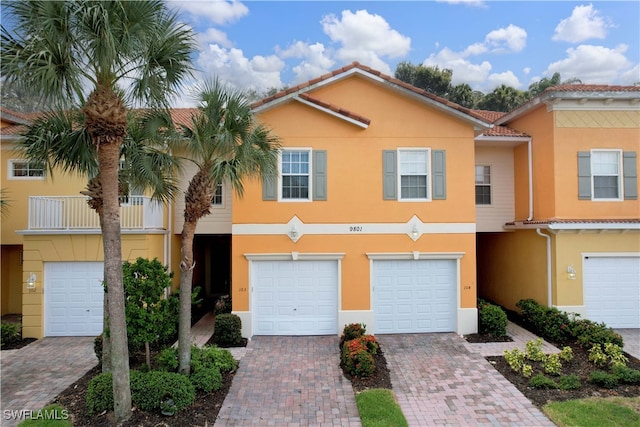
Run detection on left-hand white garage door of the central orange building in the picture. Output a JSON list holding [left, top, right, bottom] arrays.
[[251, 261, 338, 335]]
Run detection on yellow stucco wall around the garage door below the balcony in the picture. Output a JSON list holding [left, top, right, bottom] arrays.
[[22, 234, 164, 338]]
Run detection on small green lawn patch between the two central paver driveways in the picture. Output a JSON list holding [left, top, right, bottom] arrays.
[[356, 388, 408, 427]]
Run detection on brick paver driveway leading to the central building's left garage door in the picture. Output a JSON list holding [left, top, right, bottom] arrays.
[[215, 336, 361, 426]]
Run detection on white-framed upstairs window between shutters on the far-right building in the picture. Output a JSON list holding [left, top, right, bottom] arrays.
[[591, 150, 622, 200]]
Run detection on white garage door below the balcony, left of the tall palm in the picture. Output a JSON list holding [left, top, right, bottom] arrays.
[[44, 262, 104, 336]]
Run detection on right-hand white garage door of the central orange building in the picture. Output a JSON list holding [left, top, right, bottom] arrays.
[[373, 260, 457, 334]]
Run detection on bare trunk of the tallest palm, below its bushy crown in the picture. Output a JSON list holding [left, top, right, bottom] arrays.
[[98, 142, 131, 423]]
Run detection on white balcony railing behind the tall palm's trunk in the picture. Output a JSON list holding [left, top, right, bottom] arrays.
[[29, 196, 163, 230]]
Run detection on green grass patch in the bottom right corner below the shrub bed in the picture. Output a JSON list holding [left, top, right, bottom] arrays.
[[542, 397, 640, 427]]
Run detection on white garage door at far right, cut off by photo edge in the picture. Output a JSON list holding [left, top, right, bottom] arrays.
[[583, 256, 640, 328]]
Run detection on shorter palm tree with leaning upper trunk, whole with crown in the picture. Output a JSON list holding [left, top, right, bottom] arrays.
[[176, 80, 279, 374]]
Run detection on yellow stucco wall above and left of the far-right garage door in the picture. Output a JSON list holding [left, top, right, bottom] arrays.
[[554, 231, 640, 306]]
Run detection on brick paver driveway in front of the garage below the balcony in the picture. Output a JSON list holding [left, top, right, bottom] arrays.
[[0, 337, 98, 427]]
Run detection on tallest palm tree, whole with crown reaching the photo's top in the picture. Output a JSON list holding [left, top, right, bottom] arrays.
[[0, 0, 194, 422]]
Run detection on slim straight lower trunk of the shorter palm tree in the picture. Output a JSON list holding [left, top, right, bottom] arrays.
[[178, 221, 197, 375]]
